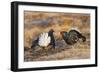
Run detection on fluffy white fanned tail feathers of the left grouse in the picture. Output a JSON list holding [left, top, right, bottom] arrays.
[[38, 33, 51, 47]]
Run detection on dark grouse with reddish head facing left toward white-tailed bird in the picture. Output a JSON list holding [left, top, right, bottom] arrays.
[[61, 29, 86, 45]]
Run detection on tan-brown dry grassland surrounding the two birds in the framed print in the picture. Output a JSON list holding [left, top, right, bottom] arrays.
[[24, 11, 90, 61]]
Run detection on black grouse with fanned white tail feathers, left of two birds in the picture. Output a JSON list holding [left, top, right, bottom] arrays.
[[31, 29, 55, 48]]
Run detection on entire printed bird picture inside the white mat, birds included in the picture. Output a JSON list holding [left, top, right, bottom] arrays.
[[24, 11, 91, 62]]
